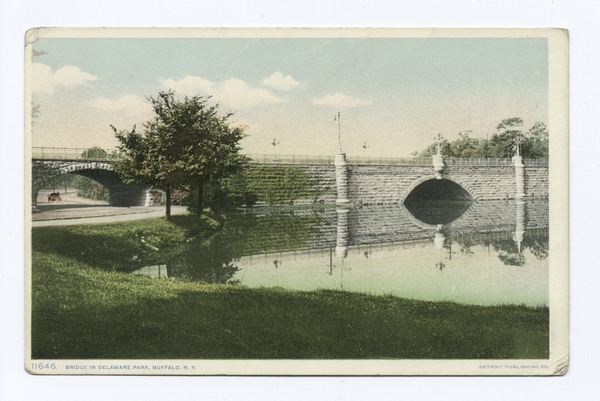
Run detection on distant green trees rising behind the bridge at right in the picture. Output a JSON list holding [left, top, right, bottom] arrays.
[[413, 117, 548, 159]]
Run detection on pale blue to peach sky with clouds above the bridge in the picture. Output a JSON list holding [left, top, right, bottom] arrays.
[[30, 32, 548, 156]]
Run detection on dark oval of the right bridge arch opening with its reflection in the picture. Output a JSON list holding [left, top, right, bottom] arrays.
[[404, 178, 473, 225]]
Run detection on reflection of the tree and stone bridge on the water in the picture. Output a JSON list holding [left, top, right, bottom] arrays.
[[131, 201, 548, 284]]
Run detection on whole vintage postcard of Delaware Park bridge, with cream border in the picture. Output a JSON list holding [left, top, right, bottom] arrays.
[[25, 28, 569, 375]]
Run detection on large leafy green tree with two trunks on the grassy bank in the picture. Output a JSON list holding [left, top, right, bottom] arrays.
[[113, 91, 247, 218]]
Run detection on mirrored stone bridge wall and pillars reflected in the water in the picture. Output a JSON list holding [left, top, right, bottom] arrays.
[[233, 199, 549, 258]]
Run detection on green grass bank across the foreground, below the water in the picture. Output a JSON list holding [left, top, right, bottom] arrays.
[[32, 220, 549, 359]]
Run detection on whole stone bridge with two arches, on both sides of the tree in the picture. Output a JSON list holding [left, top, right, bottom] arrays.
[[32, 148, 549, 206]]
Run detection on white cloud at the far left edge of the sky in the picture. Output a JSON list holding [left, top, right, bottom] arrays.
[[31, 63, 99, 94]]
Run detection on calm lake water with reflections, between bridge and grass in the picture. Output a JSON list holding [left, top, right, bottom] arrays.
[[135, 200, 548, 306]]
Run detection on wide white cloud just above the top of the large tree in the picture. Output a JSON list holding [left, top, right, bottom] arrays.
[[160, 75, 285, 109]]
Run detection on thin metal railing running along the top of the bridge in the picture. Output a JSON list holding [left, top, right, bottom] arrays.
[[31, 147, 548, 167]]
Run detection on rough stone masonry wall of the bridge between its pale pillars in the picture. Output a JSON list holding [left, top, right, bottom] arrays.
[[34, 159, 549, 205]]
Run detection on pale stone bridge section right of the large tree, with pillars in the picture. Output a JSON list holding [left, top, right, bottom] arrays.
[[244, 153, 549, 205]]
